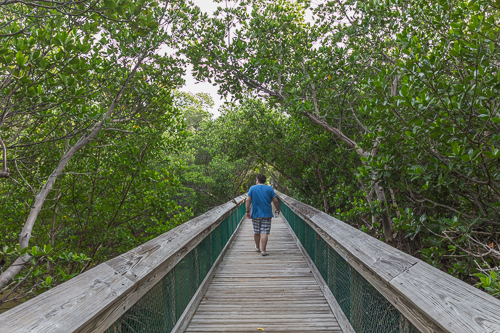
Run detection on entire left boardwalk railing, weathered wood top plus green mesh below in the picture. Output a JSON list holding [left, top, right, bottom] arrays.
[[0, 196, 245, 333]]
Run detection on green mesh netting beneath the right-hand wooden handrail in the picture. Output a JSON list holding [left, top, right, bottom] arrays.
[[279, 200, 419, 333]]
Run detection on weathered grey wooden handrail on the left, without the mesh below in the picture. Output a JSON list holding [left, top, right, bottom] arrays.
[[0, 195, 246, 333]]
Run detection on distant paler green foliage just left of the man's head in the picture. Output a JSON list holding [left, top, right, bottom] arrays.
[[171, 92, 250, 215]]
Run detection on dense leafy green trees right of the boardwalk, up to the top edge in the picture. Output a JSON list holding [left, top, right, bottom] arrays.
[[183, 0, 500, 291]]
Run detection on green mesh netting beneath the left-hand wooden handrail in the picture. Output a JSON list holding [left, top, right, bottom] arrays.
[[105, 204, 245, 333]]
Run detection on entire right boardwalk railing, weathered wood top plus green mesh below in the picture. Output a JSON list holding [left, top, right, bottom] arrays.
[[278, 192, 500, 333]]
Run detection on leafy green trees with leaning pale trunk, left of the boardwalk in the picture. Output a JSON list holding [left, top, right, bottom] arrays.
[[0, 0, 199, 305]]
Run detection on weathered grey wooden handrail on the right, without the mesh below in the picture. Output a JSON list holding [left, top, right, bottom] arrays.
[[276, 191, 500, 333]]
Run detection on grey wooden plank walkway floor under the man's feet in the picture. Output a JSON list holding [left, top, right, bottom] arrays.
[[186, 218, 342, 333]]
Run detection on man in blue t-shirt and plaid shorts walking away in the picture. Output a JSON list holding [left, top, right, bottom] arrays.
[[245, 175, 280, 256]]
